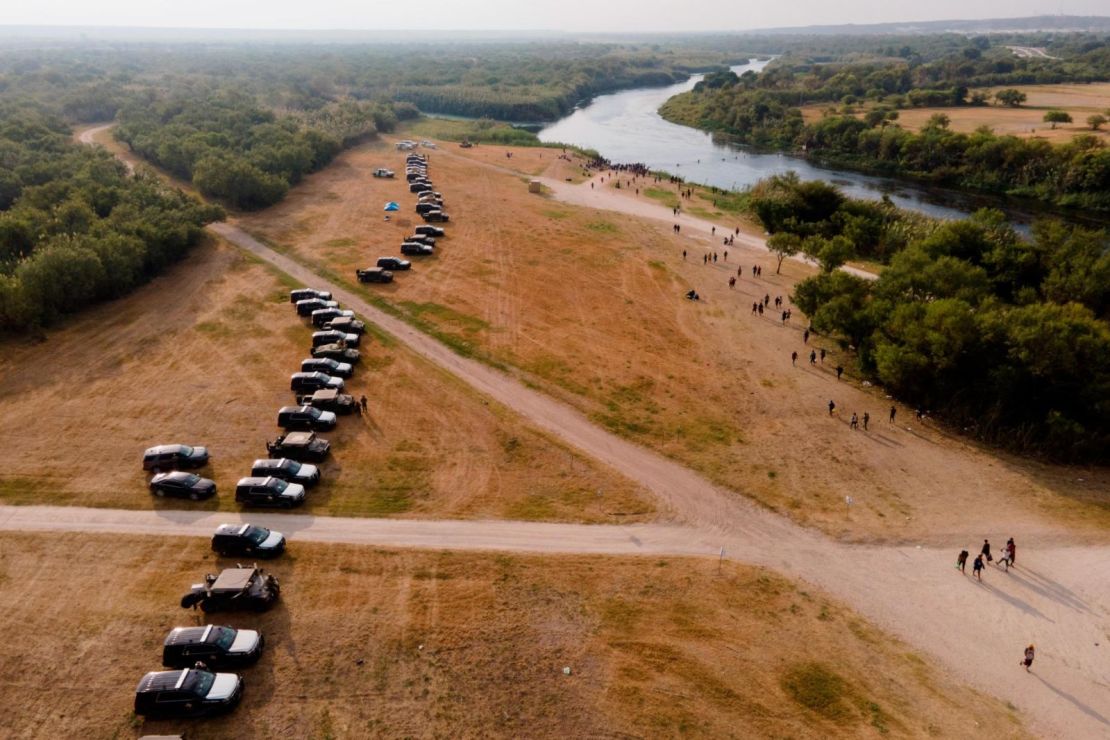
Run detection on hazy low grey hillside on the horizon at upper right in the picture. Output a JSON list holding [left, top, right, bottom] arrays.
[[744, 16, 1110, 36]]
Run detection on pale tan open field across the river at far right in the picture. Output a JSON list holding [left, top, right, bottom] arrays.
[[801, 83, 1110, 144]]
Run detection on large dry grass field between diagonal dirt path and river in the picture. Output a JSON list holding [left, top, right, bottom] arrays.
[[239, 137, 1110, 543]]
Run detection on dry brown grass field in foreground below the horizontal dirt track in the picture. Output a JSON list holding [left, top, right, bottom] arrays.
[[0, 534, 1027, 740]]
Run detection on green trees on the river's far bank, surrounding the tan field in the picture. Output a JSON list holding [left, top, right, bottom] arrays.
[[663, 37, 1110, 211]]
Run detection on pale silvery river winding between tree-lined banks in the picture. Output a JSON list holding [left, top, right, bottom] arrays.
[[538, 60, 1028, 222]]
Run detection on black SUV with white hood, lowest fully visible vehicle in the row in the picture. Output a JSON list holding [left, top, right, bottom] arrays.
[[135, 669, 243, 718]]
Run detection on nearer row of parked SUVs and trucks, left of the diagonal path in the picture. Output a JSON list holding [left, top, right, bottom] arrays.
[[134, 288, 375, 718]]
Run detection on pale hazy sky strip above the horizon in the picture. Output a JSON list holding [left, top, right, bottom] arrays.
[[0, 0, 1110, 31]]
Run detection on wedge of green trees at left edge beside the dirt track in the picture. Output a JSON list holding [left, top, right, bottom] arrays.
[[0, 107, 222, 332]]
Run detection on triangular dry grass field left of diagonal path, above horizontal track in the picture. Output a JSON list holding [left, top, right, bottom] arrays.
[[0, 244, 653, 523]]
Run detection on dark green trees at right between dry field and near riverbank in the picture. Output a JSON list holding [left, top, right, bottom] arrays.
[[749, 176, 1110, 463]]
